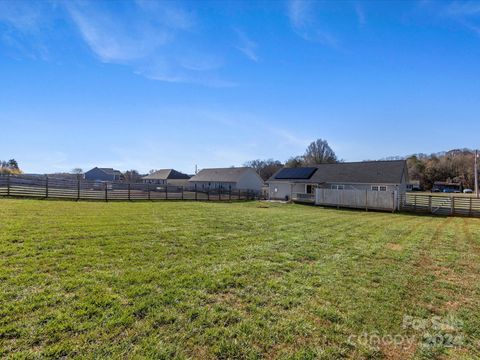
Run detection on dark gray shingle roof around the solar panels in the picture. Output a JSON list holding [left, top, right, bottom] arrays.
[[267, 160, 407, 184]]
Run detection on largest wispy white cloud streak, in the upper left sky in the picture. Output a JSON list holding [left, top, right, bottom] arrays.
[[64, 0, 232, 87]]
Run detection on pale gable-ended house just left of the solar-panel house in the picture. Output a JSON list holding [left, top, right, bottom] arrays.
[[188, 167, 263, 192]]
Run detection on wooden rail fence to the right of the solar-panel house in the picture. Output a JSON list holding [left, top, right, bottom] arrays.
[[400, 193, 480, 216]]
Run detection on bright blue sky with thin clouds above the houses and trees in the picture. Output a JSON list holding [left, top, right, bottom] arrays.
[[0, 0, 480, 173]]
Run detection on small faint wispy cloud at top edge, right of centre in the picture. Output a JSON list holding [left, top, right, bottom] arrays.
[[287, 0, 338, 47]]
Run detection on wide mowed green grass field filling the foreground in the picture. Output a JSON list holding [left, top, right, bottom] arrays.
[[0, 199, 480, 359]]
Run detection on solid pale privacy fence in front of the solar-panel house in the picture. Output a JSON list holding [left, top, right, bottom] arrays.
[[315, 189, 398, 211]]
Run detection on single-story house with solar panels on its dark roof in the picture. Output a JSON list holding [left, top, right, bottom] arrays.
[[266, 160, 408, 200]]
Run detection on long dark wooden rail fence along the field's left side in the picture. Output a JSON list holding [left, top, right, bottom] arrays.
[[0, 175, 260, 201]]
